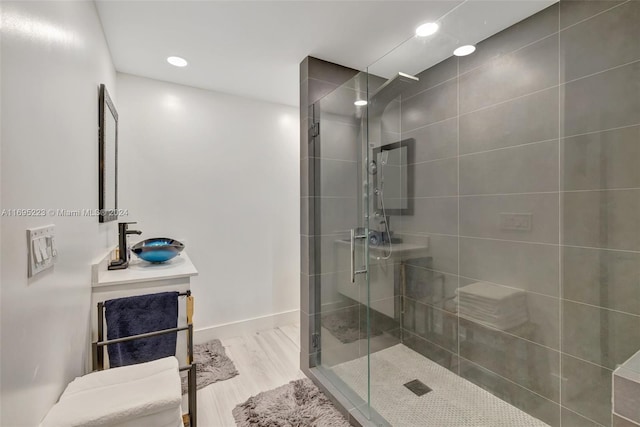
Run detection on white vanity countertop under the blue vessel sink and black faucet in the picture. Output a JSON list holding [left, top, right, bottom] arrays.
[[91, 251, 198, 288]]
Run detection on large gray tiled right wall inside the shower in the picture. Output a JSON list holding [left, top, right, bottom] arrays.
[[398, 0, 640, 427]]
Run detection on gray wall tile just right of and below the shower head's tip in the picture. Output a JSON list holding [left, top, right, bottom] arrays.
[[402, 80, 458, 132]]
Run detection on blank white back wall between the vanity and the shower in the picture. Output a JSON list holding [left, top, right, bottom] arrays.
[[117, 72, 300, 329]]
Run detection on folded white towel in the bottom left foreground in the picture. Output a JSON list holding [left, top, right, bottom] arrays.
[[41, 357, 182, 427]]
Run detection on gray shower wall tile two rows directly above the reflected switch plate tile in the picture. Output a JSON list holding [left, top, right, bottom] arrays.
[[460, 88, 559, 154]]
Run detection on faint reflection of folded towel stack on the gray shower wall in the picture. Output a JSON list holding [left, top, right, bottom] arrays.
[[456, 282, 529, 330]]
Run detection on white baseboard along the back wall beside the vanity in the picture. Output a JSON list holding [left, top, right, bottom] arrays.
[[193, 310, 300, 344]]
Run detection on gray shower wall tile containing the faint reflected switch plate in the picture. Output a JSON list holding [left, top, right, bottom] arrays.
[[460, 193, 558, 244]]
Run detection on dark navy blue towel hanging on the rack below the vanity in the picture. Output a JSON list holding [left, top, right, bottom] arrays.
[[104, 292, 178, 368]]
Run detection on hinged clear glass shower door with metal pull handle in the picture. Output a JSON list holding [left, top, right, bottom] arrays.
[[309, 73, 376, 420]]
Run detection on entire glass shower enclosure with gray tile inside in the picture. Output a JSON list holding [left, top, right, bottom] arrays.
[[309, 0, 640, 427]]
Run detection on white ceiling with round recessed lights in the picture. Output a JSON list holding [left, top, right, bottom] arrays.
[[96, 0, 555, 106]]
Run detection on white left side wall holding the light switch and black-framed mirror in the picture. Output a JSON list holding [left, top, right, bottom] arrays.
[[0, 2, 117, 427]]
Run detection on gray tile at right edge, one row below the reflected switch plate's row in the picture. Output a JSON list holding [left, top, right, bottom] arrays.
[[562, 247, 640, 316]]
